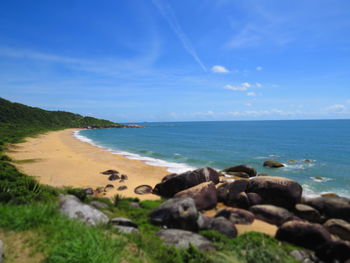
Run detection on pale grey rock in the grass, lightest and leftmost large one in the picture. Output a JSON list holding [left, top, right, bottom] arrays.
[[58, 195, 109, 226]]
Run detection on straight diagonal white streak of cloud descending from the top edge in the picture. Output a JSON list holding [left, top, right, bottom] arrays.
[[152, 0, 207, 71]]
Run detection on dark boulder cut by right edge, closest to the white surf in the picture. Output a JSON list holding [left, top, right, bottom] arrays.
[[304, 196, 350, 222]]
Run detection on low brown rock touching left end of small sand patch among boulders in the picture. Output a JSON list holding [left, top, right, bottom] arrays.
[[215, 207, 254, 225]]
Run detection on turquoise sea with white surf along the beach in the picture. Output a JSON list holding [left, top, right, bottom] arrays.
[[76, 120, 350, 196]]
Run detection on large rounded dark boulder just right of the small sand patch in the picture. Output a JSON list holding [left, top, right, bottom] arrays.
[[276, 221, 331, 250]]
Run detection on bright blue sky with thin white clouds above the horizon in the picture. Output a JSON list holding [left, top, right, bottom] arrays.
[[0, 0, 350, 122]]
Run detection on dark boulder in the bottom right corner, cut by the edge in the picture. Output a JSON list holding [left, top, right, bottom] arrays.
[[316, 240, 350, 263]]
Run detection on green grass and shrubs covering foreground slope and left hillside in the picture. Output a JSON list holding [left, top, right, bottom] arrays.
[[0, 99, 296, 263]]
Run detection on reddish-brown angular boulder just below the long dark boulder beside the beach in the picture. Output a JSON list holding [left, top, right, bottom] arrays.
[[174, 182, 218, 210]]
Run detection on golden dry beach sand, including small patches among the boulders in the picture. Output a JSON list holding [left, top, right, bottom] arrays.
[[8, 129, 277, 236]]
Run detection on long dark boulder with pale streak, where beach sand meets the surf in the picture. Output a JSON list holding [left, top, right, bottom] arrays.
[[154, 167, 220, 197]]
